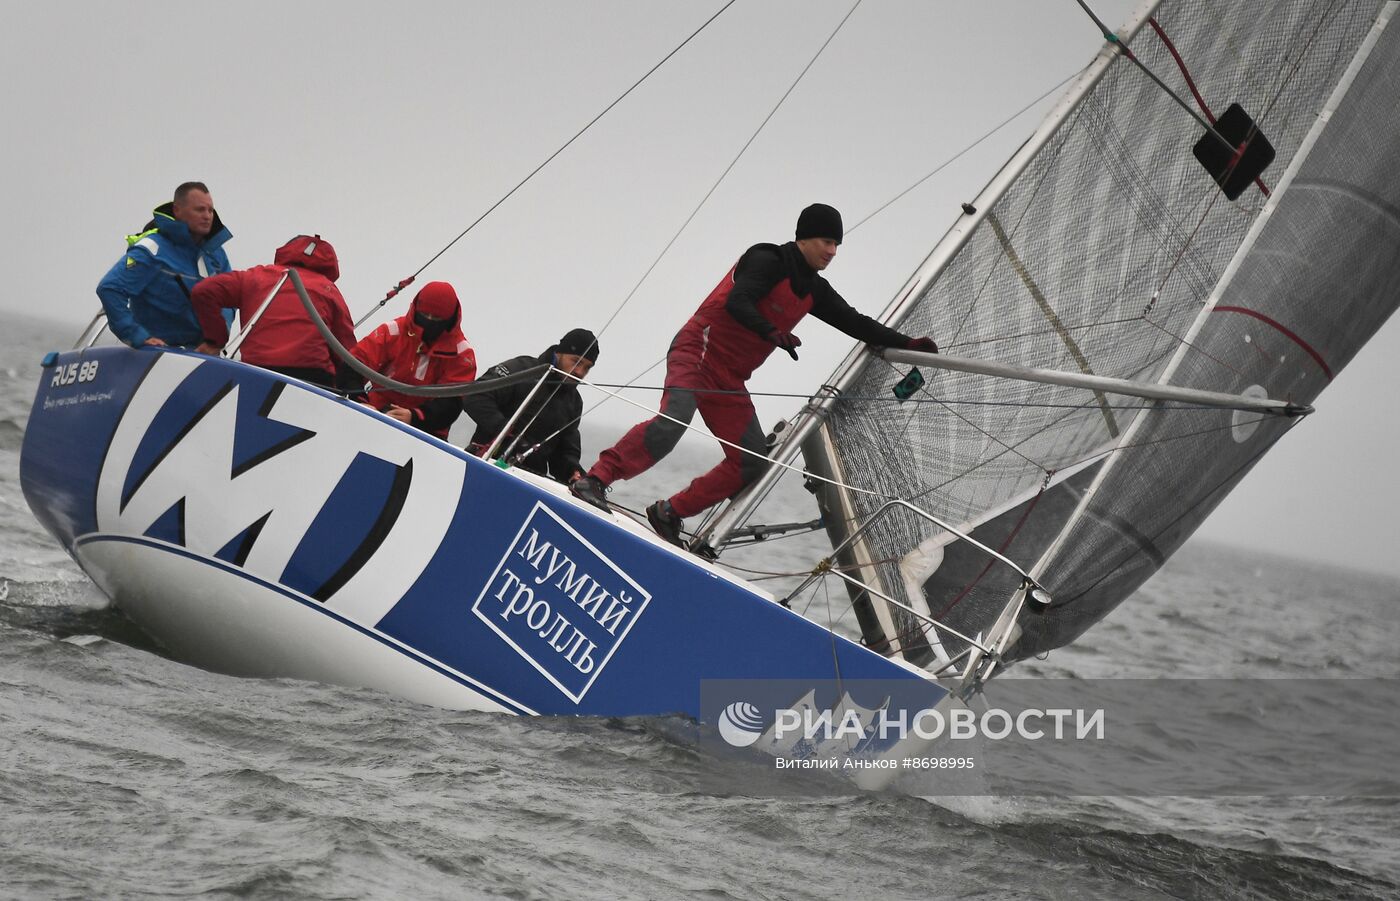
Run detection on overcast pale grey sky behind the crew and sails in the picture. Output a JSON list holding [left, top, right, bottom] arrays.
[[0, 0, 1400, 574]]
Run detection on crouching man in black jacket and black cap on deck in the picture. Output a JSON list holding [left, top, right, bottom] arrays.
[[462, 329, 598, 483]]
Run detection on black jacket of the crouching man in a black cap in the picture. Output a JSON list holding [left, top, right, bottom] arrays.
[[462, 347, 584, 483]]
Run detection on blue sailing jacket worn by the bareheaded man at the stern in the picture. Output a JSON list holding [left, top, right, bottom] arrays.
[[97, 203, 232, 347]]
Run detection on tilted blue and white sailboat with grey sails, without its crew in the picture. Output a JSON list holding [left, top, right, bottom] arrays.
[[21, 0, 1400, 772]]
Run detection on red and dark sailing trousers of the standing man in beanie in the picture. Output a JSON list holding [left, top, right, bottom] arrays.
[[588, 327, 767, 518]]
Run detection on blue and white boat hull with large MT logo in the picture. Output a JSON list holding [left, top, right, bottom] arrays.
[[21, 347, 944, 719]]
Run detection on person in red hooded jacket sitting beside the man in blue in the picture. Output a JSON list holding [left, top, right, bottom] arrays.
[[189, 235, 354, 388]]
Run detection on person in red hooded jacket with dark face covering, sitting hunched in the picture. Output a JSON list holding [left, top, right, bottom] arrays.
[[354, 281, 476, 439]]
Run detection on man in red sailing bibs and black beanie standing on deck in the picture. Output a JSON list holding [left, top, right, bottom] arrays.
[[570, 203, 938, 546]]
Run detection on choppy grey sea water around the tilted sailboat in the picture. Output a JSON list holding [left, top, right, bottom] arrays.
[[0, 316, 1400, 898]]
